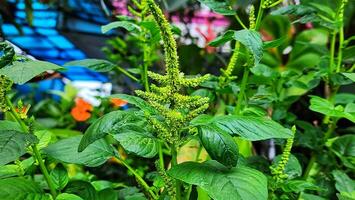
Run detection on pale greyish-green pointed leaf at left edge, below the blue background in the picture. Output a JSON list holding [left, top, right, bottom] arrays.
[[0, 60, 63, 85]]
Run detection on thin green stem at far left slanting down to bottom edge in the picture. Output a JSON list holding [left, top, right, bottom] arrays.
[[6, 97, 57, 199]]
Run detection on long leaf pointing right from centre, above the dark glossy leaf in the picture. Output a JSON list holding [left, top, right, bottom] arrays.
[[191, 115, 292, 141]]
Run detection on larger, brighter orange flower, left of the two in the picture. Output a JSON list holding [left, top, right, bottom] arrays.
[[70, 98, 93, 122]]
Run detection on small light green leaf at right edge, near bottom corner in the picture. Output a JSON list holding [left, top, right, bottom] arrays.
[[332, 170, 355, 193]]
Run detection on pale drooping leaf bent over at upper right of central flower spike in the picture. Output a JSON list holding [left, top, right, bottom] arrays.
[[209, 30, 263, 65]]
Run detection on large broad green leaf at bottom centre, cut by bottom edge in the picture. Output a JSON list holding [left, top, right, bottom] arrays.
[[167, 160, 268, 200]]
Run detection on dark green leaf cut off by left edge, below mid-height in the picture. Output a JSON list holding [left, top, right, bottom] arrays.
[[0, 130, 37, 166]]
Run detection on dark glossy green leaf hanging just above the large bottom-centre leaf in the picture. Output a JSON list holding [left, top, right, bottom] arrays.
[[199, 125, 239, 168]]
